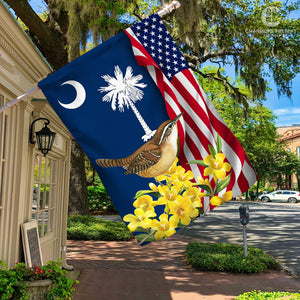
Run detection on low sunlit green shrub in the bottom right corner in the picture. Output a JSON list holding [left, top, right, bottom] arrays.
[[235, 291, 300, 300]]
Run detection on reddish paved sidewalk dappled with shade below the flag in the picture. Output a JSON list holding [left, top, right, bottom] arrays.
[[67, 235, 300, 300]]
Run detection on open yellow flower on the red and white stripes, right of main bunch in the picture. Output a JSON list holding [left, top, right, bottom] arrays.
[[204, 153, 231, 180]]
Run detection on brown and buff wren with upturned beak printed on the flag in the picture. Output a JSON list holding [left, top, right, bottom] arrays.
[[96, 114, 182, 177]]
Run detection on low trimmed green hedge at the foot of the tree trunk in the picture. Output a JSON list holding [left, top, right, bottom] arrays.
[[67, 215, 133, 241]]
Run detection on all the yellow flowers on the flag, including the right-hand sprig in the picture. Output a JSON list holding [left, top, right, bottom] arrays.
[[123, 136, 232, 243]]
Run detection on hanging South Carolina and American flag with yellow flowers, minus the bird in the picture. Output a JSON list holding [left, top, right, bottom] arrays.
[[38, 14, 256, 244]]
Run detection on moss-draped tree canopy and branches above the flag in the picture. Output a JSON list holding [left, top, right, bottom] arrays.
[[5, 0, 300, 107]]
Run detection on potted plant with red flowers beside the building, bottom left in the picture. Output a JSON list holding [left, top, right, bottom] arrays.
[[0, 261, 74, 300]]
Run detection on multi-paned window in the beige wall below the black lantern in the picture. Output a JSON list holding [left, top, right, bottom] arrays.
[[32, 154, 57, 237]]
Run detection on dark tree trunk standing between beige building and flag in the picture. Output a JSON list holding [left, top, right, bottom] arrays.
[[68, 140, 89, 215]]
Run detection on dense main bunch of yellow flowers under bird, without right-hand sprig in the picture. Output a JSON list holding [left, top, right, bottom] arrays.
[[123, 158, 205, 240]]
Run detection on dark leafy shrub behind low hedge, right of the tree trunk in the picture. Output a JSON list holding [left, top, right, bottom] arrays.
[[87, 183, 117, 213]]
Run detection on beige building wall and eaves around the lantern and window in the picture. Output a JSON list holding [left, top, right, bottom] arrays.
[[0, 0, 71, 267]]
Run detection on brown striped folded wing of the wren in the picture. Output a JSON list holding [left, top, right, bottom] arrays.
[[125, 147, 161, 174]]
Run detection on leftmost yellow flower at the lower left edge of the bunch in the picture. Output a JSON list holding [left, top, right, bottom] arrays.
[[123, 208, 156, 231]]
